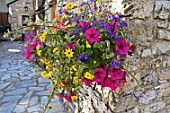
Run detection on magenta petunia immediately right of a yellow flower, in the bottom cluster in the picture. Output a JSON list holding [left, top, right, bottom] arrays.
[[93, 68, 106, 83]]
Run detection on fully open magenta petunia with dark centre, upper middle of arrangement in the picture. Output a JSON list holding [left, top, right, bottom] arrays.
[[84, 28, 100, 43]]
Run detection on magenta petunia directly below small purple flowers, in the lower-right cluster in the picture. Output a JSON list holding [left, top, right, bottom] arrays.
[[108, 66, 125, 80]]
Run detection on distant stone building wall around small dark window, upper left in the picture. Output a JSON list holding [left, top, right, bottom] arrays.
[[9, 0, 34, 30]]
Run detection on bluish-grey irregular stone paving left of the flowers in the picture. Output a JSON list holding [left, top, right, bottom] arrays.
[[0, 41, 70, 113]]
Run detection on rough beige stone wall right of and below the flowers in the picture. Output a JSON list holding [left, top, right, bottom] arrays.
[[64, 0, 170, 113]]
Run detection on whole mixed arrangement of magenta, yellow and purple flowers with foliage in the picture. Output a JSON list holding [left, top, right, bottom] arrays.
[[23, 0, 136, 102]]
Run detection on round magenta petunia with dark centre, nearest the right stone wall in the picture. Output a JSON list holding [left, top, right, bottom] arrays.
[[115, 39, 130, 55]]
